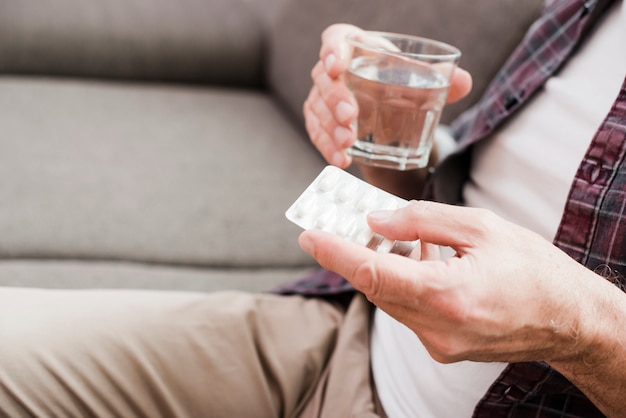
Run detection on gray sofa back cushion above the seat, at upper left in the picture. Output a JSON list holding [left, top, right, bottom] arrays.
[[0, 0, 283, 85]]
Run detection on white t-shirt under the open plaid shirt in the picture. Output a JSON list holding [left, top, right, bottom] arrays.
[[371, 2, 626, 418]]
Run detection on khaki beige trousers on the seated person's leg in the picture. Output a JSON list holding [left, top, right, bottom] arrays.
[[0, 288, 384, 418]]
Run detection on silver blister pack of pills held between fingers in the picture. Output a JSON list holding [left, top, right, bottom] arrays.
[[285, 166, 416, 256]]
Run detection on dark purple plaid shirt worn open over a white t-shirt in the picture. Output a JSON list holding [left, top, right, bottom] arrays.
[[279, 0, 626, 418]]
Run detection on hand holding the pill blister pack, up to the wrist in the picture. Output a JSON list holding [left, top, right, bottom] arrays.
[[300, 202, 610, 363]]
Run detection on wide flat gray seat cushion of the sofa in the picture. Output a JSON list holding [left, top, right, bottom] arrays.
[[0, 77, 324, 268]]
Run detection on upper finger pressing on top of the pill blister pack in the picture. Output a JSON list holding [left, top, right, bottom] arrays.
[[368, 201, 497, 251]]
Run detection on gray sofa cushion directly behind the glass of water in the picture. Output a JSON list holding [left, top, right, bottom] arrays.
[[269, 0, 543, 123]]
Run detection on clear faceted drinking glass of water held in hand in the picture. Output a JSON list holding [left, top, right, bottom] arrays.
[[346, 31, 461, 170]]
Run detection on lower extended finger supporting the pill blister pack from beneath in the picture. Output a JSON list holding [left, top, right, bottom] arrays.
[[298, 230, 428, 305]]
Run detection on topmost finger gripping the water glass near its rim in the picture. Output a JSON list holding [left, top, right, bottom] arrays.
[[320, 23, 363, 78]]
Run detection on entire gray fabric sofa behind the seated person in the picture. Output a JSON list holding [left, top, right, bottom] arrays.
[[0, 0, 541, 291]]
